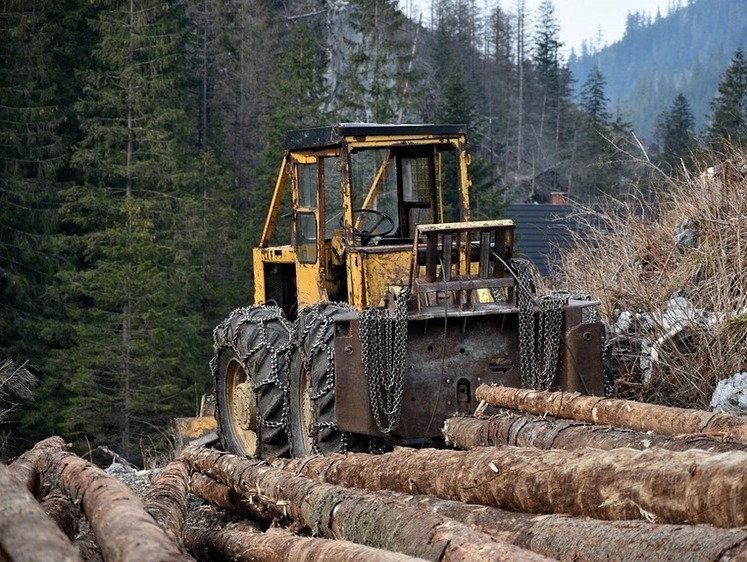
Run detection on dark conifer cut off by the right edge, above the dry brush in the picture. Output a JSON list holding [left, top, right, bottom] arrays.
[[706, 49, 747, 152]]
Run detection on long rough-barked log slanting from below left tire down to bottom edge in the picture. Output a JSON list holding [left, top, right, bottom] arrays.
[[182, 447, 545, 561]]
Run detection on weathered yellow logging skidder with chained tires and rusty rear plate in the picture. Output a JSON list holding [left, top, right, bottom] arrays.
[[200, 123, 604, 458]]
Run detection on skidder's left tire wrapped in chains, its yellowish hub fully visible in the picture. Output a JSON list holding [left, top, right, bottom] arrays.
[[210, 305, 294, 458]]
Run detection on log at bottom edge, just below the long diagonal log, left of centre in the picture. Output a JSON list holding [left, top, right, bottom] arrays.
[[187, 506, 430, 562]]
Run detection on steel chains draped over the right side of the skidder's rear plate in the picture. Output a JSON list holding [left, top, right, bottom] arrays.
[[511, 258, 598, 390]]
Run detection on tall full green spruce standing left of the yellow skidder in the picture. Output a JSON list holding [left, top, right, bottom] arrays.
[[52, 0, 210, 459]]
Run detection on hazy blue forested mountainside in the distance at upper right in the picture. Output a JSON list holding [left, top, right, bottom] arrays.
[[569, 0, 747, 139]]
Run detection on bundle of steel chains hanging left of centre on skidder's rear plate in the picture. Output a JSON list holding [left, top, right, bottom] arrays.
[[360, 289, 410, 435]]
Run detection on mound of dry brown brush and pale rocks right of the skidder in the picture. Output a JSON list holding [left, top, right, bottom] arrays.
[[554, 153, 747, 408]]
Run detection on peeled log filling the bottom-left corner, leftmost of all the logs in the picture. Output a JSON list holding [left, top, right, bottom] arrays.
[[0, 464, 81, 562]]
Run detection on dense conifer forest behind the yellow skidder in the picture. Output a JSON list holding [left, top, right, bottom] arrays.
[[0, 0, 747, 463]]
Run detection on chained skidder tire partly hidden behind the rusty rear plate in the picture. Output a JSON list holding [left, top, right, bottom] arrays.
[[288, 302, 370, 457]]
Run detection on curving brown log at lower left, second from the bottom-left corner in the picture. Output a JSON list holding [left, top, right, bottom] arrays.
[[36, 442, 192, 562]]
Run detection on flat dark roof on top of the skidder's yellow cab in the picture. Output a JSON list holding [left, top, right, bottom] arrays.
[[285, 123, 467, 150]]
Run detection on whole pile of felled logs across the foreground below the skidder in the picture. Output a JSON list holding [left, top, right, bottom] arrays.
[[0, 386, 747, 561]]
